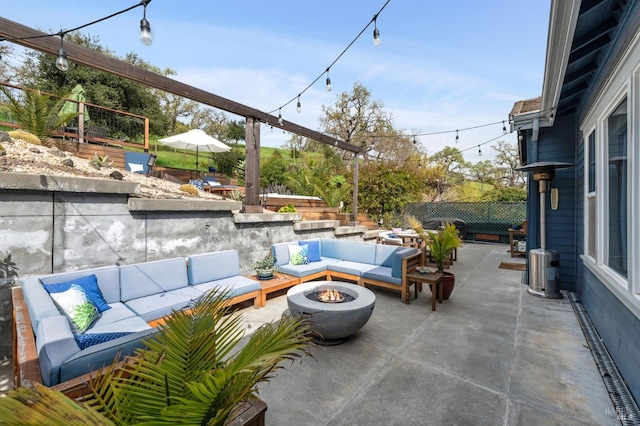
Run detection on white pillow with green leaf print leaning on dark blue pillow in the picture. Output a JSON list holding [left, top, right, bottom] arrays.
[[49, 284, 100, 335]]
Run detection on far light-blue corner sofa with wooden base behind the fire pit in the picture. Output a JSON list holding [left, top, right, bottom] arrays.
[[271, 239, 421, 301]]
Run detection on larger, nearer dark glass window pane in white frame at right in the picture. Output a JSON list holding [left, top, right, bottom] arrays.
[[606, 97, 629, 278]]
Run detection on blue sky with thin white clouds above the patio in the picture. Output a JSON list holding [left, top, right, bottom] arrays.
[[0, 0, 550, 163]]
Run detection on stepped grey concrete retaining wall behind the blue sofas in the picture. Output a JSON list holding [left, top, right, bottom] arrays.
[[0, 173, 366, 359]]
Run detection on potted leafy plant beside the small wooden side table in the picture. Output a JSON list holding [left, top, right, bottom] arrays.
[[409, 217, 462, 299]]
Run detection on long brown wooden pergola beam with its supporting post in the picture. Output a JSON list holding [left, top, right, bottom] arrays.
[[0, 17, 362, 216]]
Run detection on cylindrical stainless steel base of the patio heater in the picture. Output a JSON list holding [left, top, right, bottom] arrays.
[[527, 249, 562, 299]]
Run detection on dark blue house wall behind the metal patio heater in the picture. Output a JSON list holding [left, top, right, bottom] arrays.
[[527, 117, 577, 291]]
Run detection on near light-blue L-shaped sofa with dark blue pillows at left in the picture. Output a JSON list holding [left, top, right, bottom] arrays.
[[18, 250, 261, 386]]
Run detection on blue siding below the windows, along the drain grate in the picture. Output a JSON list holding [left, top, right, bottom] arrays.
[[576, 268, 640, 401]]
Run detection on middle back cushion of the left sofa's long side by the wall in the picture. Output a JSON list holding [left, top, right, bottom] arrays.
[[120, 257, 189, 302]]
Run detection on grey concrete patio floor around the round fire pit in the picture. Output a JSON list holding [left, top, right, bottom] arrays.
[[242, 243, 620, 426]]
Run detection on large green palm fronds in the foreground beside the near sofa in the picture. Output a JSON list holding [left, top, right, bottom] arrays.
[[0, 292, 310, 425]]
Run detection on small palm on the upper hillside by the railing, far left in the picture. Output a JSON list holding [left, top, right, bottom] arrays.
[[0, 86, 78, 141]]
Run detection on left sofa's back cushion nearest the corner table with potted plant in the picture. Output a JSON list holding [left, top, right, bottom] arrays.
[[187, 250, 240, 285]]
